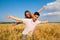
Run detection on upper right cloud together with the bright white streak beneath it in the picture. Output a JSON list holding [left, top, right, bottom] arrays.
[[43, 0, 60, 16]]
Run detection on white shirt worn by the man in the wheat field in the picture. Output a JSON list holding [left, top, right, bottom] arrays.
[[22, 19, 41, 35]]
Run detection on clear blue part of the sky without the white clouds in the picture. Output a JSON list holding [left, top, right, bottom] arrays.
[[0, 0, 57, 22]]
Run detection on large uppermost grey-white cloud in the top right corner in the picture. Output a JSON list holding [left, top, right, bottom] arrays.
[[46, 1, 60, 12]]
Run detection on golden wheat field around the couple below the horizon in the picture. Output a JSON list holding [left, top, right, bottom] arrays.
[[0, 23, 60, 40]]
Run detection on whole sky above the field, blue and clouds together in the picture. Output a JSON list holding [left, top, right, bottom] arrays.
[[0, 0, 60, 22]]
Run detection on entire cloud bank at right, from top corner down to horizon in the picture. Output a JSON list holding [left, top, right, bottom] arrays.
[[41, 0, 60, 22]]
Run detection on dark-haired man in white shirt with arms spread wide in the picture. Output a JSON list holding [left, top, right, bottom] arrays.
[[7, 12, 47, 40]]
